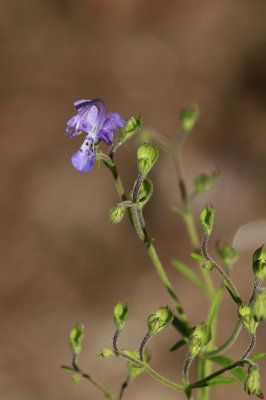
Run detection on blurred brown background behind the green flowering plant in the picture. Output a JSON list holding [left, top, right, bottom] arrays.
[[0, 0, 266, 400]]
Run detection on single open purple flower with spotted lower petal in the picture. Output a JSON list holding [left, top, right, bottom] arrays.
[[65, 99, 125, 172]]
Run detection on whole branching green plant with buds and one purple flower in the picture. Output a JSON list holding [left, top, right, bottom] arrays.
[[62, 99, 266, 400]]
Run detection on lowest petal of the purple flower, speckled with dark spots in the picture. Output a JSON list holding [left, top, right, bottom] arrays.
[[71, 136, 95, 172]]
